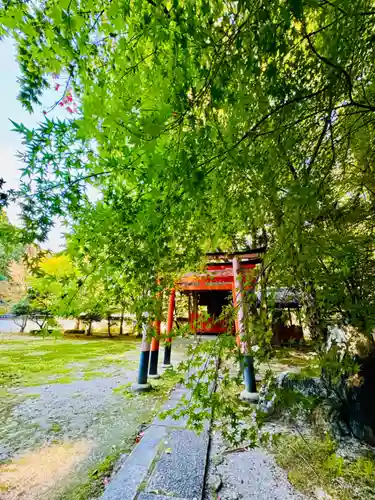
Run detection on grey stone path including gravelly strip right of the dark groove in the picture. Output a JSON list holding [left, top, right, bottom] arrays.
[[101, 342, 305, 500]]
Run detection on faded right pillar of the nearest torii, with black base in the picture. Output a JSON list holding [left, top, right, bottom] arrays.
[[232, 257, 257, 401]]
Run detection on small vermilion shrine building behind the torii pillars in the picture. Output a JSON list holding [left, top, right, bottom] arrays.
[[176, 248, 266, 334]]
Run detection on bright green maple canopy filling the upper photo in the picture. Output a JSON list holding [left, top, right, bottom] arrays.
[[0, 0, 375, 333]]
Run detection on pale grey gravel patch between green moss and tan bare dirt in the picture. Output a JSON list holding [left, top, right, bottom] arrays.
[[0, 367, 136, 460]]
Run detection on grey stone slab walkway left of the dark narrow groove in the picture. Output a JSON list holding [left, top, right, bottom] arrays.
[[102, 387, 209, 500]]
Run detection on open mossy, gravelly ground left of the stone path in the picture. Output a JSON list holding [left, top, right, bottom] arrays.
[[0, 334, 185, 500]]
